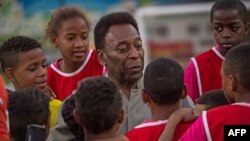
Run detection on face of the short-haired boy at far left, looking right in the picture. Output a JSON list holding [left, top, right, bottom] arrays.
[[11, 48, 47, 90]]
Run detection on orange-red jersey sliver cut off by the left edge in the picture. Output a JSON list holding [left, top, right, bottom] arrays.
[[0, 76, 10, 140]]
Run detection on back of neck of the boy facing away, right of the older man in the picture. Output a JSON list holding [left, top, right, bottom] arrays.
[[150, 102, 180, 121]]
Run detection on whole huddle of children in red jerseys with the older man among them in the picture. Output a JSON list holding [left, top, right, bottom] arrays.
[[0, 0, 250, 141]]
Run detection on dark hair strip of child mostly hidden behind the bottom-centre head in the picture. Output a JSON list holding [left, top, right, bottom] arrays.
[[62, 94, 84, 141]]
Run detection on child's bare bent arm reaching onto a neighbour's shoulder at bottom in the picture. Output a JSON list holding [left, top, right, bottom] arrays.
[[158, 108, 196, 141]]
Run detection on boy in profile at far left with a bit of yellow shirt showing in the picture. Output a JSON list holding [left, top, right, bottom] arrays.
[[0, 36, 61, 127]]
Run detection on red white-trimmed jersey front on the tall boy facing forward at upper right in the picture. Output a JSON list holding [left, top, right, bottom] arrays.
[[191, 47, 224, 95]]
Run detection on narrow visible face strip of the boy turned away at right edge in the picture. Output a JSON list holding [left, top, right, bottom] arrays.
[[221, 67, 235, 103]]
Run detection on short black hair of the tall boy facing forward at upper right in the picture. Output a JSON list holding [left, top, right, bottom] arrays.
[[210, 0, 248, 24]]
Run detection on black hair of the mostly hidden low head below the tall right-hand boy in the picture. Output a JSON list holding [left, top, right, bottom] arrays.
[[196, 90, 229, 110]]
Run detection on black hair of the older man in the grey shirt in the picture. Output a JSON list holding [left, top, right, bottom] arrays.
[[94, 12, 139, 50]]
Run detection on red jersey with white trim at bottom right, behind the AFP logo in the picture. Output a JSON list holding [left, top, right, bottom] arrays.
[[202, 103, 250, 141]]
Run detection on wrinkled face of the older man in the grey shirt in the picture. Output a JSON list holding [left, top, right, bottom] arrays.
[[100, 24, 144, 83]]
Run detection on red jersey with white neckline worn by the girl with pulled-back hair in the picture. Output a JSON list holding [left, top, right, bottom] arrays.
[[47, 50, 105, 100]]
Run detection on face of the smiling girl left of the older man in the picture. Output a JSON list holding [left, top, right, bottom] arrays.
[[52, 18, 89, 64]]
